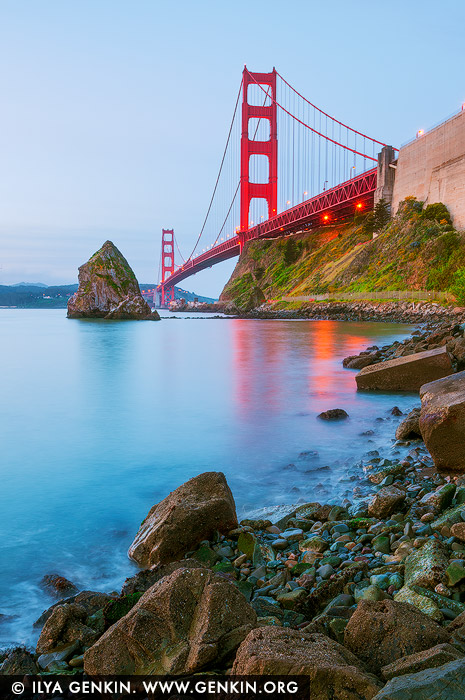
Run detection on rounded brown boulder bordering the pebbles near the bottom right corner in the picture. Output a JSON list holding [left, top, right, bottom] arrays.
[[344, 600, 449, 674]]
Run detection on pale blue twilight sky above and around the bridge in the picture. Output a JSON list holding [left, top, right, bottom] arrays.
[[0, 0, 465, 296]]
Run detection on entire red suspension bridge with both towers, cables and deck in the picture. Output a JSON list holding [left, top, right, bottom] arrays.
[[157, 67, 396, 306]]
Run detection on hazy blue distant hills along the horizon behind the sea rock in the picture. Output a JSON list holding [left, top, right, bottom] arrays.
[[0, 282, 216, 309]]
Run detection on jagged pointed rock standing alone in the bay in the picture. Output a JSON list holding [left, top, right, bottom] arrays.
[[68, 241, 160, 321]]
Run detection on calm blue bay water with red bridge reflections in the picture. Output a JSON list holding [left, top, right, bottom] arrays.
[[0, 310, 415, 644]]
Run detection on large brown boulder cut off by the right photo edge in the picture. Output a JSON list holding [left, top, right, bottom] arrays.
[[420, 372, 465, 473]]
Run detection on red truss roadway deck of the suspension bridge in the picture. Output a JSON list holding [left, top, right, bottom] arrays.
[[163, 168, 377, 289]]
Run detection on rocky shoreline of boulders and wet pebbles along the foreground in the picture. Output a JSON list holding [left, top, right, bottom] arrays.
[[0, 320, 465, 700]]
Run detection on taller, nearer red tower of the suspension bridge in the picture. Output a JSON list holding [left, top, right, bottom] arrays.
[[239, 66, 278, 250]]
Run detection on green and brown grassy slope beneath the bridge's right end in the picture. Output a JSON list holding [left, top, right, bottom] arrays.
[[221, 201, 465, 306]]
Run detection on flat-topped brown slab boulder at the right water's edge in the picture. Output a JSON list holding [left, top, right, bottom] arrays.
[[355, 346, 453, 391]]
